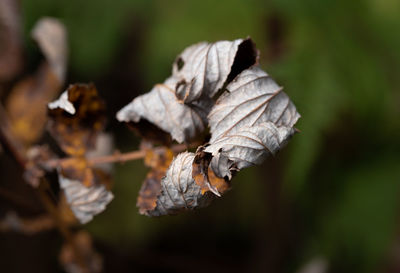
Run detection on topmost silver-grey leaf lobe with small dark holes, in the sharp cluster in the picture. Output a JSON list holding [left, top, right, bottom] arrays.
[[172, 39, 256, 103]]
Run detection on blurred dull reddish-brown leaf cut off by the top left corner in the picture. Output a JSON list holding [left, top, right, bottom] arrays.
[[0, 0, 23, 83]]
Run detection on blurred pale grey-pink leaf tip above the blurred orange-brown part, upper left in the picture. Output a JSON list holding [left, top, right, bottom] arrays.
[[32, 17, 68, 83]]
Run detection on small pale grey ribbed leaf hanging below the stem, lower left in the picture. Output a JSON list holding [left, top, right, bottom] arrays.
[[59, 173, 114, 224]]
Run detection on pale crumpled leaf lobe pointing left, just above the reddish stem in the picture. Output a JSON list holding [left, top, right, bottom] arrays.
[[117, 77, 206, 143]]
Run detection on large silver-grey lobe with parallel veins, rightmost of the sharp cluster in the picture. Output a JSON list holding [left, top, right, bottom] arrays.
[[208, 66, 300, 143]]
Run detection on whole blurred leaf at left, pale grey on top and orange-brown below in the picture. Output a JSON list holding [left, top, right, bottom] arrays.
[[6, 18, 67, 146]]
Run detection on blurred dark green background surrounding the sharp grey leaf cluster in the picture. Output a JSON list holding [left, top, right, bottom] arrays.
[[5, 0, 400, 273]]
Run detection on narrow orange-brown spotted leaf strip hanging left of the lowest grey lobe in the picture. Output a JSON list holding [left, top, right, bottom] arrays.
[[136, 148, 174, 214]]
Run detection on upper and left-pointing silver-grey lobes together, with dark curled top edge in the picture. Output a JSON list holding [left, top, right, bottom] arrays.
[[117, 39, 258, 143]]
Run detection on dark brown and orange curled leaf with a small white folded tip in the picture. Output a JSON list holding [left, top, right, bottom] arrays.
[[48, 84, 105, 156]]
